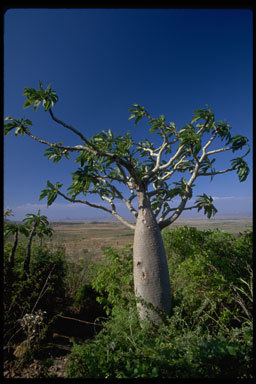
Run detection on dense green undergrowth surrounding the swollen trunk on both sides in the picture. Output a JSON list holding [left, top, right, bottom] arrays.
[[4, 227, 253, 378]]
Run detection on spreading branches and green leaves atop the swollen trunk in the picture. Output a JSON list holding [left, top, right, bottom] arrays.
[[5, 82, 250, 229]]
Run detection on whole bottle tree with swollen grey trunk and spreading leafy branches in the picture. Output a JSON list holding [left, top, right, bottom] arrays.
[[5, 82, 250, 323]]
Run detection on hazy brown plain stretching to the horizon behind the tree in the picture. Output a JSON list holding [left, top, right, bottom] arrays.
[[44, 217, 252, 261]]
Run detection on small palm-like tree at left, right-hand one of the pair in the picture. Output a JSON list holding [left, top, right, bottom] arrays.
[[23, 210, 50, 274]]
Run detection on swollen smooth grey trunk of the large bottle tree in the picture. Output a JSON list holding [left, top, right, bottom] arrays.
[[133, 192, 171, 323]]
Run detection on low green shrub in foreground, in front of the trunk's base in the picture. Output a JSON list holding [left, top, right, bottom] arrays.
[[68, 306, 252, 378]]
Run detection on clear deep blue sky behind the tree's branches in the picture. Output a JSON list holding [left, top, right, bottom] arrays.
[[4, 9, 252, 220]]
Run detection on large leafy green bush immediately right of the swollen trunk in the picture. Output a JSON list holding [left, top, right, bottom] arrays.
[[163, 227, 252, 329]]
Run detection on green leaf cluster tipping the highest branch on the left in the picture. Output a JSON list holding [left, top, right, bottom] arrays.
[[23, 81, 58, 111]]
